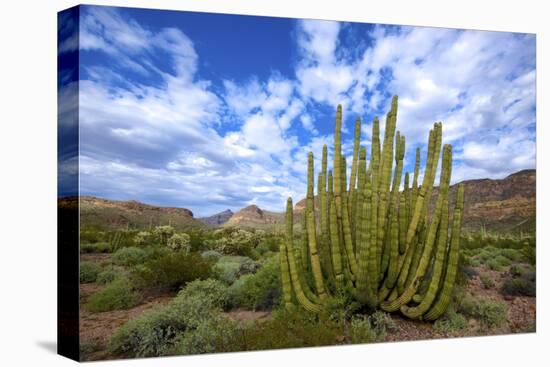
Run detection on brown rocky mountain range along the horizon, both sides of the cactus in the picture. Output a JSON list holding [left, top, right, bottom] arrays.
[[60, 170, 536, 233]]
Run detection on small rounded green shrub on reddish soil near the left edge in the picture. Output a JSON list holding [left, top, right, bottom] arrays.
[[86, 277, 142, 312]]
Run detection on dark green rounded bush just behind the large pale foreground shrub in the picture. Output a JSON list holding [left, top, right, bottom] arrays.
[[131, 252, 210, 291]]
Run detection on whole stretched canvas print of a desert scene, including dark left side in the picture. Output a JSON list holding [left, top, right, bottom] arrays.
[[58, 5, 536, 360]]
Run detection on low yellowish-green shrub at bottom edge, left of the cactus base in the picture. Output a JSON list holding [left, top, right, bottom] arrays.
[[242, 309, 343, 350]]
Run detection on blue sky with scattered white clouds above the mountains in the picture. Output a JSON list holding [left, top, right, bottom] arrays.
[[59, 6, 536, 216]]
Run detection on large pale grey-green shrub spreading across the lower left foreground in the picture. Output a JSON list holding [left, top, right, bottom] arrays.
[[108, 279, 230, 357]]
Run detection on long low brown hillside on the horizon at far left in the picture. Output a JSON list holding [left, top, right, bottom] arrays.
[[59, 196, 205, 230]]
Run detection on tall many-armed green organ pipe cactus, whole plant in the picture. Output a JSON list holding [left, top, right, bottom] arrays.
[[280, 96, 464, 320]]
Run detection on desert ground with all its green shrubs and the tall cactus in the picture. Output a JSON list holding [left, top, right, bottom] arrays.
[[80, 99, 536, 360]]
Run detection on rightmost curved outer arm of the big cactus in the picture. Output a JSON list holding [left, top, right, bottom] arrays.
[[424, 184, 464, 320]]
